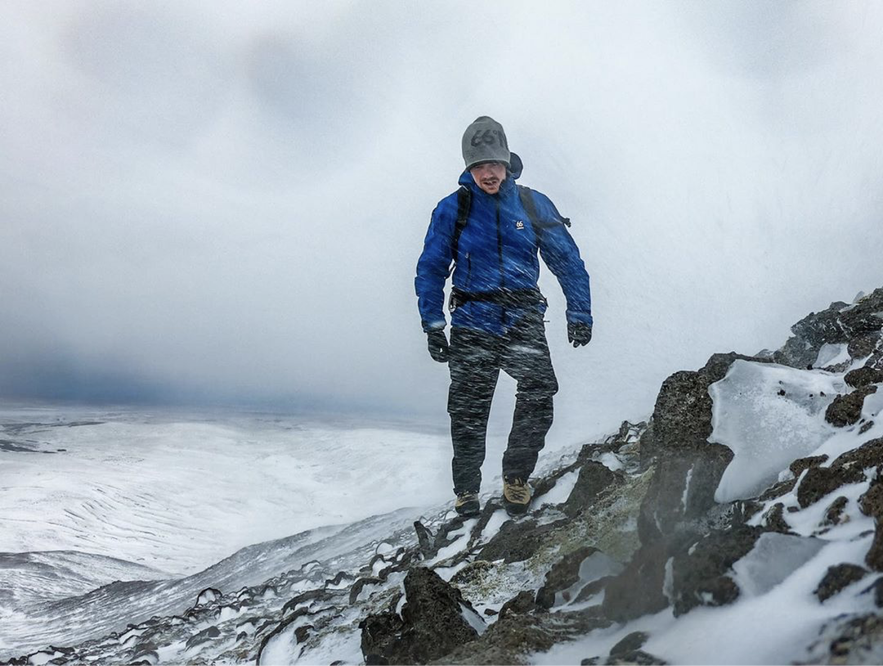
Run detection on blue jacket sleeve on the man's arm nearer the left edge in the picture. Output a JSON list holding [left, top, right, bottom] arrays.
[[414, 199, 456, 332]]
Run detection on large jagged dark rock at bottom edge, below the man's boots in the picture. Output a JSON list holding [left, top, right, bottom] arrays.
[[360, 567, 478, 666]]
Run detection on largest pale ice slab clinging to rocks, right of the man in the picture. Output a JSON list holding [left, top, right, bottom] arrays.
[[708, 360, 846, 502]]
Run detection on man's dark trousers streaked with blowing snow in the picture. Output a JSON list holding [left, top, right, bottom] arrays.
[[448, 313, 558, 493]]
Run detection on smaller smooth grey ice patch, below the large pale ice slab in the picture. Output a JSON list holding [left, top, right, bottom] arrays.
[[733, 532, 825, 597]]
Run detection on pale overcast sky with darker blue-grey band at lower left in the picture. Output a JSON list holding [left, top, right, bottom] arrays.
[[0, 0, 883, 438]]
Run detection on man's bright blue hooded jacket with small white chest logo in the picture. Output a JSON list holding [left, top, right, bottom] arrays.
[[414, 165, 592, 335]]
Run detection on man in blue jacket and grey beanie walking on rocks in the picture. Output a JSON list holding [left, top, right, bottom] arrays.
[[415, 116, 592, 516]]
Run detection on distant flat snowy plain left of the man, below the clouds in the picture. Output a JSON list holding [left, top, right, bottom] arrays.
[[0, 407, 462, 575]]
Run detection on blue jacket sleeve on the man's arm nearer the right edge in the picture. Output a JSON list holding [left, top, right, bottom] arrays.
[[535, 192, 592, 326]]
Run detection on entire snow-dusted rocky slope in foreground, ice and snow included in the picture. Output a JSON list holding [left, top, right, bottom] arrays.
[[0, 289, 883, 666]]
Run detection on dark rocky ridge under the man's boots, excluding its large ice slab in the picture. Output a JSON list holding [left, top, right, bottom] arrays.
[[0, 289, 883, 666]]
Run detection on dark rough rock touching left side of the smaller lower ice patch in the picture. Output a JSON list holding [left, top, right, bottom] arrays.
[[672, 525, 763, 616]]
